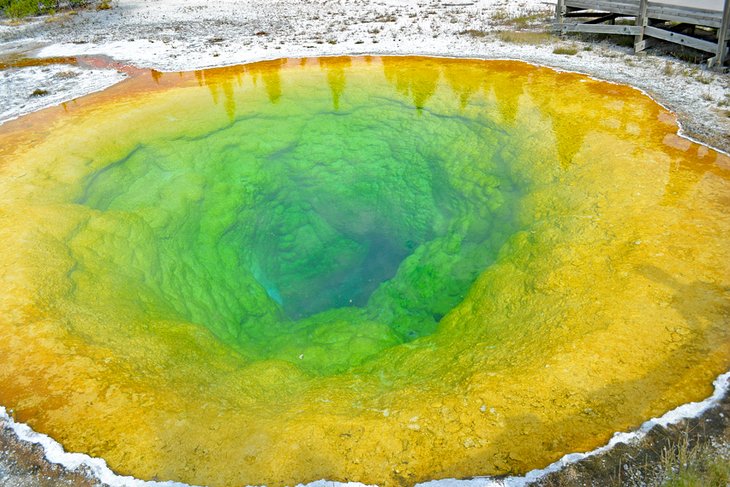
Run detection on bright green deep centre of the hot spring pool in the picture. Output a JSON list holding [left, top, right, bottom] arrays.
[[72, 66, 521, 373]]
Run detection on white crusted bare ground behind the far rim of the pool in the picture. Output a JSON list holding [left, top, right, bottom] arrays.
[[0, 0, 730, 150]]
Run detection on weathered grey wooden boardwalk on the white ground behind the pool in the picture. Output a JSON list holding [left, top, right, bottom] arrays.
[[556, 0, 730, 67]]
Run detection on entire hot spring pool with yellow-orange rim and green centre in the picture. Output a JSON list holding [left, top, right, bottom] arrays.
[[0, 57, 730, 486]]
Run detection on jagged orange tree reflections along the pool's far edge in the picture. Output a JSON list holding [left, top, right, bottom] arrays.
[[156, 56, 727, 204]]
